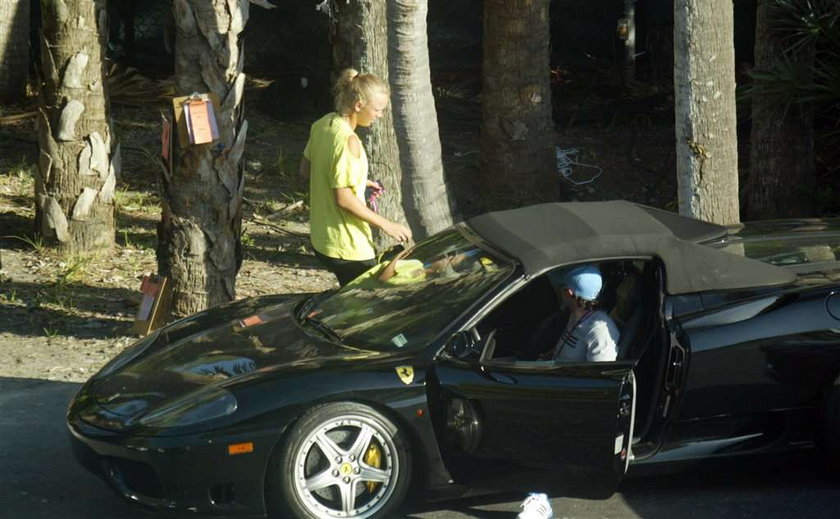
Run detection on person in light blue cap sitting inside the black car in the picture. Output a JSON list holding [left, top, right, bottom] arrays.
[[541, 265, 619, 362]]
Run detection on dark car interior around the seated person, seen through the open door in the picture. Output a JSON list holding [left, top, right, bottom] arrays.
[[472, 259, 667, 448]]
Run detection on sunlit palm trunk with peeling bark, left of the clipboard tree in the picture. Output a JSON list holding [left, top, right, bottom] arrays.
[[35, 0, 119, 253]]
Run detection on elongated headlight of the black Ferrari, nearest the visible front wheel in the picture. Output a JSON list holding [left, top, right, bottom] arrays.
[[140, 387, 238, 428]]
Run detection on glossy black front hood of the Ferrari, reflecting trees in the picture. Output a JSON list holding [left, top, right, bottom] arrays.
[[90, 296, 389, 419]]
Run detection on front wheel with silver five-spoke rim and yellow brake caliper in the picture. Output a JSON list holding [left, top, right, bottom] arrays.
[[268, 402, 411, 519]]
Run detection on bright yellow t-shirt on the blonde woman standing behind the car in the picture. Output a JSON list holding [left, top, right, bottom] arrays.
[[303, 113, 376, 261]]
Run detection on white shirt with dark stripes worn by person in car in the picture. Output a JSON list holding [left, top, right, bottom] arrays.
[[554, 310, 619, 362]]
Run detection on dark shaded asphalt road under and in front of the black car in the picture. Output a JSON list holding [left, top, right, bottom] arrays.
[[0, 378, 840, 519]]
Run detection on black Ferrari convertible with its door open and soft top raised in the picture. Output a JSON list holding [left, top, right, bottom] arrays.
[[67, 202, 840, 518]]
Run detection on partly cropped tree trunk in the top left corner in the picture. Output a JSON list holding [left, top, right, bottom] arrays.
[[0, 0, 29, 103]]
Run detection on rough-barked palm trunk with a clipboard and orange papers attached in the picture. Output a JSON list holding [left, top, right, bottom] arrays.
[[158, 0, 249, 316]]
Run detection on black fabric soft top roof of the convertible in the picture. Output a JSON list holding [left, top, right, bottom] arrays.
[[467, 201, 796, 294]]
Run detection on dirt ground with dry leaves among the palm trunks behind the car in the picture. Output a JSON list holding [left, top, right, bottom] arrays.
[[0, 75, 675, 381]]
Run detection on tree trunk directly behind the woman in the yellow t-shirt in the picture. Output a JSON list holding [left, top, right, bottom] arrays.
[[331, 0, 406, 251]]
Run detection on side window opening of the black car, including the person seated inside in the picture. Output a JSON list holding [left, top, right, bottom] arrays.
[[476, 260, 659, 366]]
